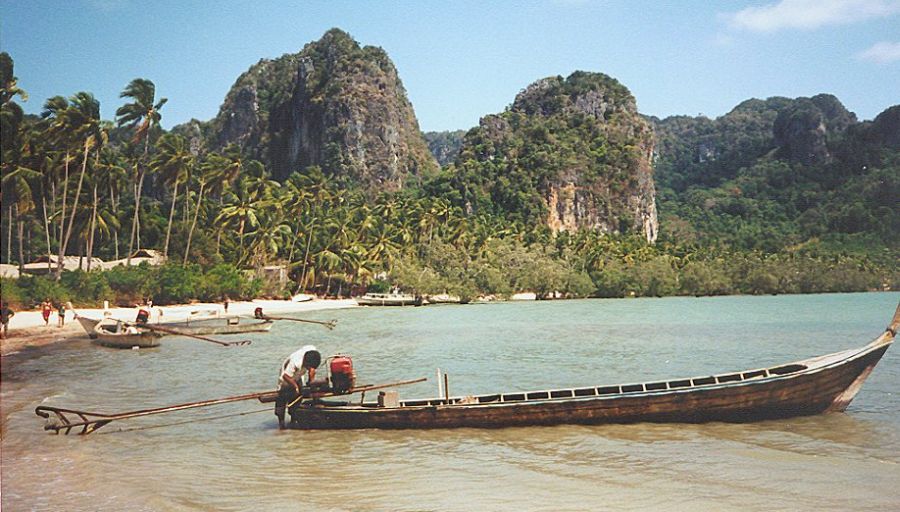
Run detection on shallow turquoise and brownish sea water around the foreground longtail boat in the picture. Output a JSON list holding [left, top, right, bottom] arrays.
[[0, 293, 900, 511]]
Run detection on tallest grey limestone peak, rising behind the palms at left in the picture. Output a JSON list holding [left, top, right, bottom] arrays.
[[211, 29, 437, 188]]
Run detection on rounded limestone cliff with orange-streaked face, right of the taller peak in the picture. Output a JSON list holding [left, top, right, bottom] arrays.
[[456, 72, 658, 241]]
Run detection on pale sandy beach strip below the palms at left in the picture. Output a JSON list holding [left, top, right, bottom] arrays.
[[0, 299, 357, 356]]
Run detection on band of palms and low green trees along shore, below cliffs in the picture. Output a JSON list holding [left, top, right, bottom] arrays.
[[0, 54, 900, 308]]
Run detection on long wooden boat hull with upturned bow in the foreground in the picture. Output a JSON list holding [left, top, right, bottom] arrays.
[[290, 307, 900, 429]]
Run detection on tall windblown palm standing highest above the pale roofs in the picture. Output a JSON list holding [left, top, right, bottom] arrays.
[[116, 78, 168, 265]]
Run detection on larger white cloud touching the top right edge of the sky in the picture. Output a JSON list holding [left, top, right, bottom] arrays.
[[723, 0, 900, 32]]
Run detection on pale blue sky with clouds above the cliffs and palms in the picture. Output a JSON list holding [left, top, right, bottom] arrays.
[[0, 0, 900, 131]]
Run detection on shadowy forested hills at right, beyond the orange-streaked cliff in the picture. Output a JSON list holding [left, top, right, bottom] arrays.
[[654, 95, 900, 252]]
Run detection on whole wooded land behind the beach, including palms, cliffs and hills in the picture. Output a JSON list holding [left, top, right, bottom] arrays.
[[0, 30, 900, 305]]
